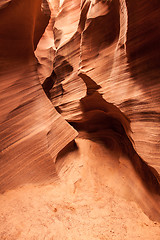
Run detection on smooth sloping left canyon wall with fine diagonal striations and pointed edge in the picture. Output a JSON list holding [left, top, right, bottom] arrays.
[[0, 0, 77, 192]]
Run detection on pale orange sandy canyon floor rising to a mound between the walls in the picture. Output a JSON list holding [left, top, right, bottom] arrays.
[[0, 139, 160, 240]]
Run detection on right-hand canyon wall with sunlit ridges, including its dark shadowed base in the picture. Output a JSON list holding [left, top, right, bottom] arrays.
[[35, 0, 160, 219]]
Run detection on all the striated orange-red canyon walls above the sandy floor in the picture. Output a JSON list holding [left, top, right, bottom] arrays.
[[0, 0, 160, 199]]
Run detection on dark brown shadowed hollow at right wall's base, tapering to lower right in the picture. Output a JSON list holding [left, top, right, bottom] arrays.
[[69, 74, 160, 195]]
